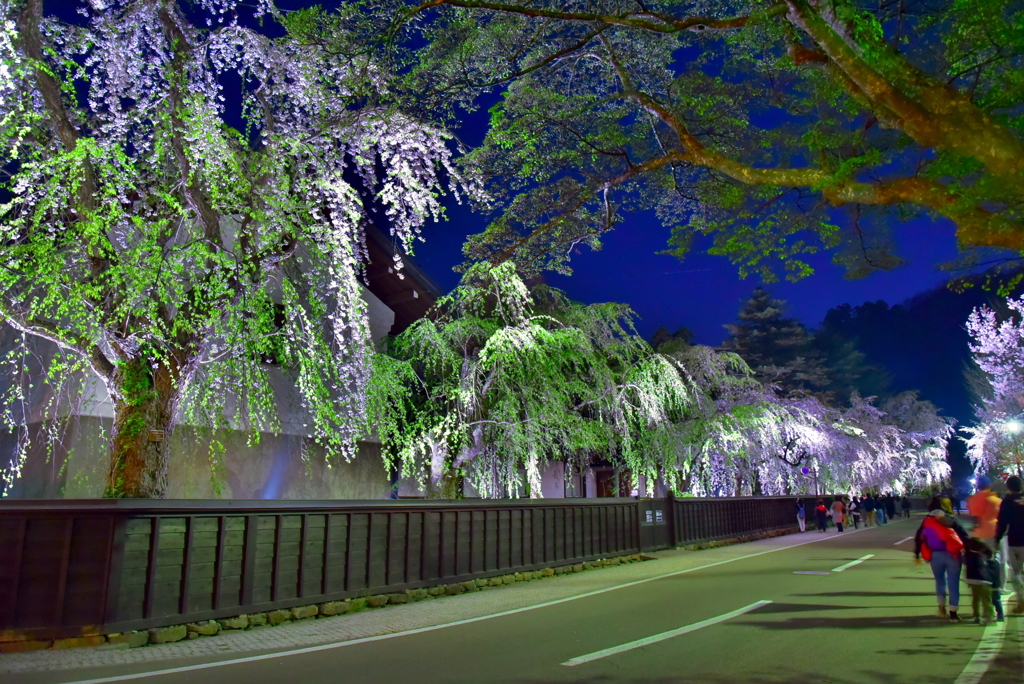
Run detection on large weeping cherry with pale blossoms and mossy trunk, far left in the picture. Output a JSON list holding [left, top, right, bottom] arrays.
[[0, 0, 471, 497]]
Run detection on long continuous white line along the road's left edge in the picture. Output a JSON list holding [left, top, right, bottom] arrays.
[[51, 527, 888, 684]]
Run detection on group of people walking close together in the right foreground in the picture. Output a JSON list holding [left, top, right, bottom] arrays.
[[913, 475, 1024, 623]]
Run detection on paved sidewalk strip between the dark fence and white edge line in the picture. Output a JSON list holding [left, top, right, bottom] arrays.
[[0, 521, 910, 675]]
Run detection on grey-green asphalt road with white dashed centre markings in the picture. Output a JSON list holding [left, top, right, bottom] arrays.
[[5, 520, 1024, 684]]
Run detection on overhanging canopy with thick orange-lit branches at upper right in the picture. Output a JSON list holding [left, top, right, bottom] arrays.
[[385, 0, 1024, 281]]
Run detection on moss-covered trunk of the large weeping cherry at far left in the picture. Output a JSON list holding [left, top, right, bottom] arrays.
[[103, 354, 178, 499]]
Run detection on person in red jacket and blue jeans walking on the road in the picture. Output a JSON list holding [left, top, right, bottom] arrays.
[[913, 497, 964, 623]]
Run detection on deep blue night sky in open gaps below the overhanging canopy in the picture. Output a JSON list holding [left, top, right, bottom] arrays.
[[405, 109, 956, 346]]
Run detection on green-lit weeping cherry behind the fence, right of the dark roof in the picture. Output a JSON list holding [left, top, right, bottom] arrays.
[[368, 262, 699, 497]]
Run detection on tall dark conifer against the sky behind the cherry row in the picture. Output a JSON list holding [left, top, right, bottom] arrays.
[[723, 288, 829, 394]]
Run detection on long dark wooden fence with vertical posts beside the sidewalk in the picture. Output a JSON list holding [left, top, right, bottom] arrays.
[[0, 498, 831, 641]]
